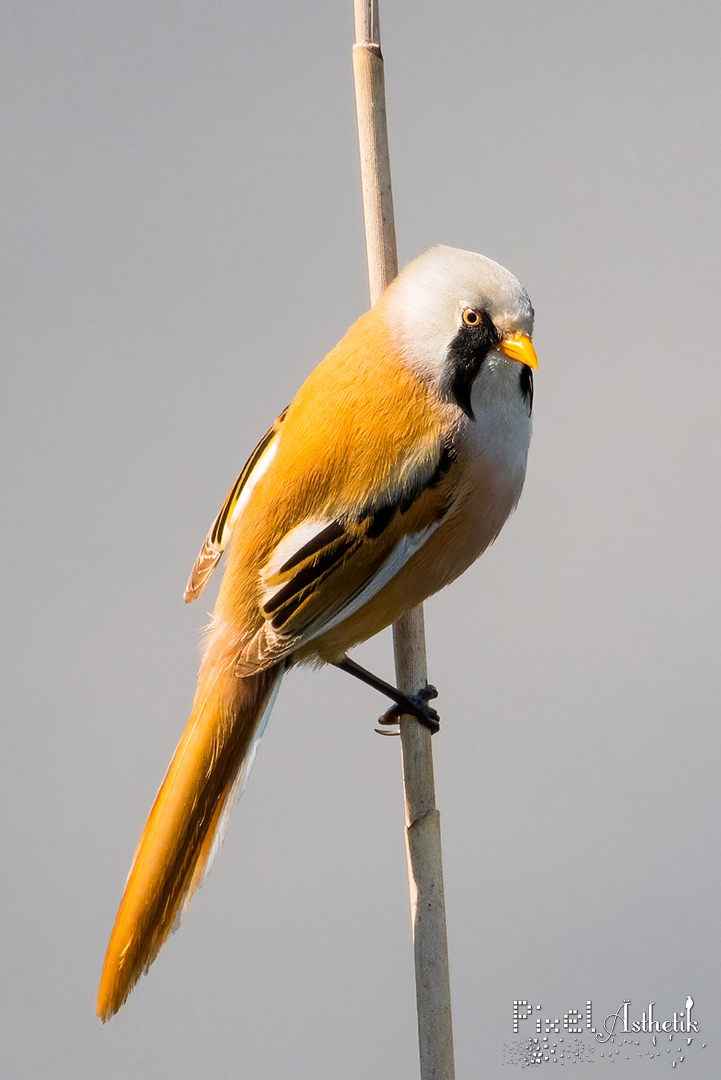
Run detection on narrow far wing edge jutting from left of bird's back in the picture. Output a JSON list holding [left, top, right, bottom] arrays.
[[183, 408, 288, 604]]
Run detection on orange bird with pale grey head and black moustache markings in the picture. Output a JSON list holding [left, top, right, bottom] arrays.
[[96, 245, 538, 1022]]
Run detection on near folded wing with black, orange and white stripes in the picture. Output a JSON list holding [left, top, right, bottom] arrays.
[[235, 437, 455, 675]]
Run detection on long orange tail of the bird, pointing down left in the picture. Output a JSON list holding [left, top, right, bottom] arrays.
[[96, 638, 283, 1021]]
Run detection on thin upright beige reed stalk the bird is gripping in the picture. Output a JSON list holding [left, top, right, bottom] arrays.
[[353, 0, 455, 1080]]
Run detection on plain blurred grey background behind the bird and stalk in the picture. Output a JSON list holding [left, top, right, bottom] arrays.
[[0, 0, 721, 1080]]
